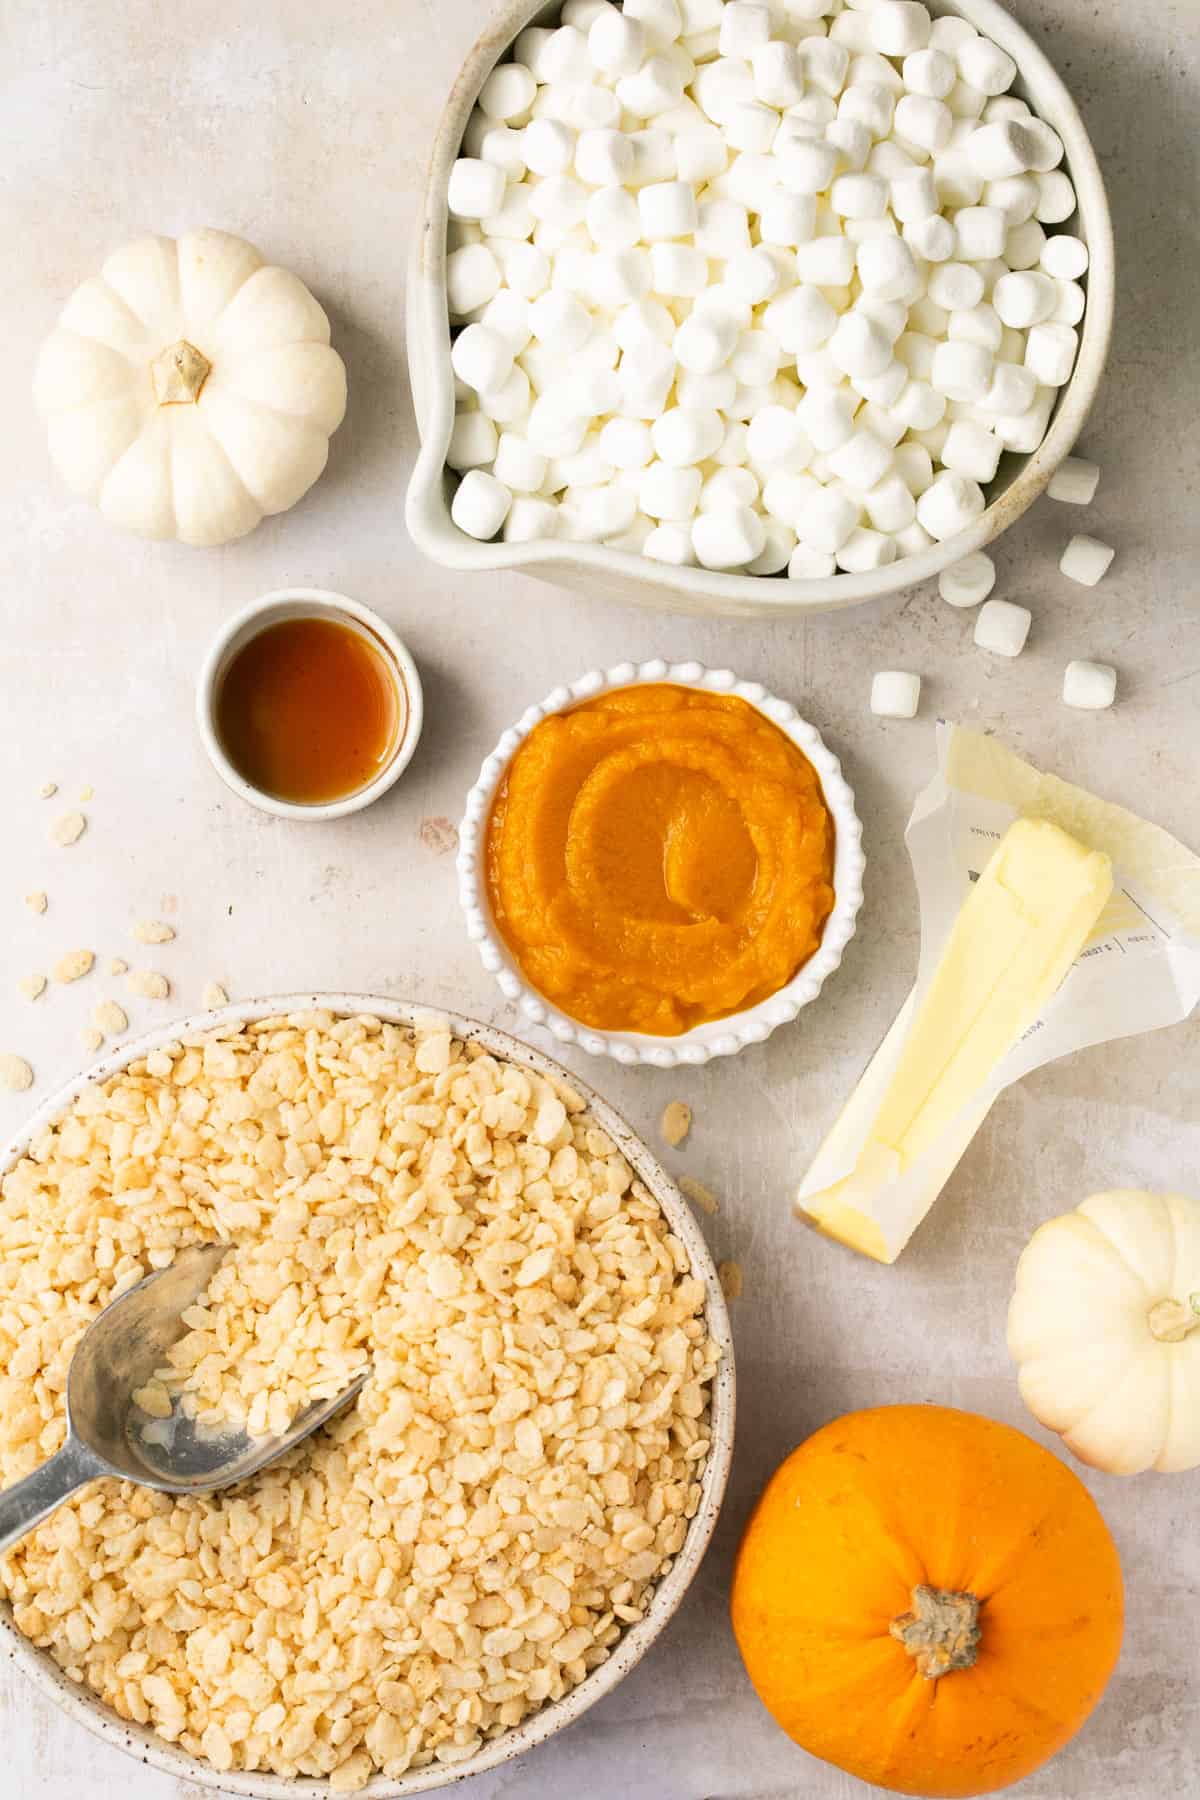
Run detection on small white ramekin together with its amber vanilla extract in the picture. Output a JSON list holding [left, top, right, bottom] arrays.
[[196, 587, 423, 819]]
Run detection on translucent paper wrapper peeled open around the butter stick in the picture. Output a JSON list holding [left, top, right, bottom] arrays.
[[795, 724, 1200, 1262]]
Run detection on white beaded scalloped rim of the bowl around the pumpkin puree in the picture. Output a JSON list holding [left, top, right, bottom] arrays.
[[459, 661, 865, 1069]]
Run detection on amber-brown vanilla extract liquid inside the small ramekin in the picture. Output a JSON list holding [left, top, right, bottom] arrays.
[[216, 617, 408, 806]]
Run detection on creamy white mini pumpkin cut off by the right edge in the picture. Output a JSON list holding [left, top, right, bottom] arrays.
[[1007, 1190, 1200, 1474]]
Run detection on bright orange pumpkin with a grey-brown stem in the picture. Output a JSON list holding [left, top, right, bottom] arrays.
[[732, 1406, 1124, 1796]]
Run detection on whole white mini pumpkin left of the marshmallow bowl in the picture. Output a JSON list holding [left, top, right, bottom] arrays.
[[34, 230, 345, 544]]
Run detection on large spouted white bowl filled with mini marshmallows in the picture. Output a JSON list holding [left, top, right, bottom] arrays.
[[407, 0, 1114, 616]]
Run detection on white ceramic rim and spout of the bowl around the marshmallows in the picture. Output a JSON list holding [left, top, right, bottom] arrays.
[[407, 0, 1114, 617]]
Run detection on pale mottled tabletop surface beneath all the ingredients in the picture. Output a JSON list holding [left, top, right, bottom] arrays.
[[0, 0, 1200, 1800]]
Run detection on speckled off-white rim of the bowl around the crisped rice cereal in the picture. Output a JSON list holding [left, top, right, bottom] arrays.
[[0, 994, 736, 1800]]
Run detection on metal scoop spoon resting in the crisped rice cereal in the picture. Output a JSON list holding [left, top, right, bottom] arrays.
[[0, 1244, 371, 1553]]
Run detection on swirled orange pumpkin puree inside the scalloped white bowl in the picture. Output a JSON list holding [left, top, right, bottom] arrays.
[[488, 684, 833, 1037]]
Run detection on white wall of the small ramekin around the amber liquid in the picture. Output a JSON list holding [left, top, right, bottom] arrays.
[[196, 587, 425, 823]]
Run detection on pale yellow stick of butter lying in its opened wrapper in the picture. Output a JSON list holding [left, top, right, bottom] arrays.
[[797, 819, 1112, 1262]]
